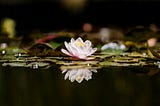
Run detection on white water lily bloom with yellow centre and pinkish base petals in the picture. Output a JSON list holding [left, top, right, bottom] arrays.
[[61, 37, 97, 60]]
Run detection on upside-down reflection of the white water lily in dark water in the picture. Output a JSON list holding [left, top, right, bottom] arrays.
[[62, 68, 97, 83]]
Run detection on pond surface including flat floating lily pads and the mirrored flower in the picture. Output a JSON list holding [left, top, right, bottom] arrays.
[[0, 45, 160, 106]]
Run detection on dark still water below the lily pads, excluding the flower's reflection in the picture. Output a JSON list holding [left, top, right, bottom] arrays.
[[0, 66, 160, 106]]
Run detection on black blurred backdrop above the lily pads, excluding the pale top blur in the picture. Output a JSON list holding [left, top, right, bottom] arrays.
[[0, 0, 160, 33]]
